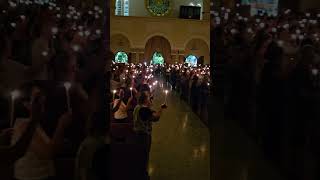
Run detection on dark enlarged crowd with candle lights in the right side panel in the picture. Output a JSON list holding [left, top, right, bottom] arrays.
[[211, 5, 320, 179]]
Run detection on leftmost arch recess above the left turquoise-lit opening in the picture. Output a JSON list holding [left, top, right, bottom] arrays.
[[110, 33, 131, 53]]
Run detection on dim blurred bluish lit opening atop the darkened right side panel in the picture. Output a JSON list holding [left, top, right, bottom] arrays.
[[241, 0, 279, 16]]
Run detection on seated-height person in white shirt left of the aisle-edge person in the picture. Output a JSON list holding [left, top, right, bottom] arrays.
[[112, 89, 132, 122]]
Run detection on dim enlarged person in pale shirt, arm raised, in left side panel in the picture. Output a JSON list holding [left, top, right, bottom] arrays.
[[12, 84, 72, 180]]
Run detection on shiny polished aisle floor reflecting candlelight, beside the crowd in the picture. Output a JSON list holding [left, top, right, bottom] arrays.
[[149, 83, 210, 180]]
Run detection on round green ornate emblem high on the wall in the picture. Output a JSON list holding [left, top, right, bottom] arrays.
[[145, 0, 172, 16]]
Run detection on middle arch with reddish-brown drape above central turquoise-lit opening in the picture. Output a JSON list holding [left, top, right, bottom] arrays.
[[144, 36, 171, 62]]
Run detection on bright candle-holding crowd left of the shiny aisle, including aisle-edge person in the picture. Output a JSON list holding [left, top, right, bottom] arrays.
[[110, 63, 169, 179]]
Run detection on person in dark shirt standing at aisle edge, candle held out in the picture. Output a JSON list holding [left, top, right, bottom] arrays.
[[133, 91, 167, 177]]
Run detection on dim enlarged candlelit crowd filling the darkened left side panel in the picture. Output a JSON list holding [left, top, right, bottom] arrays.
[[0, 0, 111, 180]]
